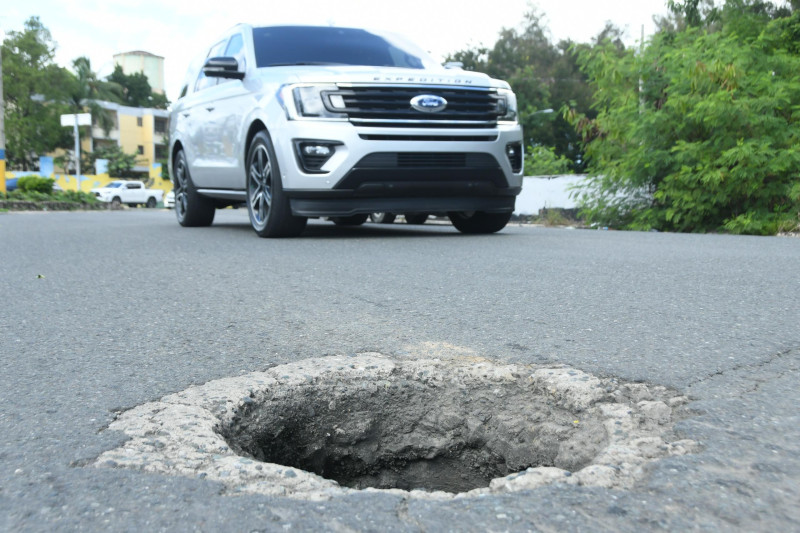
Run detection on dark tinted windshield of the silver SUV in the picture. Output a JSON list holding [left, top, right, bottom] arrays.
[[253, 26, 436, 69]]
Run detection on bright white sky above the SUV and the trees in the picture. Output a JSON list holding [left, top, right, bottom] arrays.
[[0, 0, 667, 101]]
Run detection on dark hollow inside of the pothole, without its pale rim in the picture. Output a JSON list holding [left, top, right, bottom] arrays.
[[222, 362, 608, 492]]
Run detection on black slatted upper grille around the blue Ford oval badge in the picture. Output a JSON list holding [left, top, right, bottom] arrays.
[[323, 86, 504, 128]]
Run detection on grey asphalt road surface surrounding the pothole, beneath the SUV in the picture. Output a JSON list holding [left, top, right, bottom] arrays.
[[0, 209, 800, 531]]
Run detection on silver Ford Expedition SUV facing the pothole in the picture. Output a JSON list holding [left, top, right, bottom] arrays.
[[170, 25, 523, 237]]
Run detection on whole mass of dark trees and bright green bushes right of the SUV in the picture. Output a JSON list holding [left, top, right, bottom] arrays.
[[450, 0, 800, 235]]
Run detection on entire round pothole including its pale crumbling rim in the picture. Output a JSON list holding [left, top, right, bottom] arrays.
[[95, 354, 696, 499]]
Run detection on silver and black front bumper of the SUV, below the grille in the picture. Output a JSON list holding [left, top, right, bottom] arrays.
[[273, 122, 522, 216]]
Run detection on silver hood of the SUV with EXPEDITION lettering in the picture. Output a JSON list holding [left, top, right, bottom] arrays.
[[259, 65, 509, 88]]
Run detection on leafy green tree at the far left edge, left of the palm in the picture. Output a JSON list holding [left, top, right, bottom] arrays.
[[2, 17, 71, 170]]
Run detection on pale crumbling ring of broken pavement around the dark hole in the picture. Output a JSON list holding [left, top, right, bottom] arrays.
[[92, 350, 700, 500]]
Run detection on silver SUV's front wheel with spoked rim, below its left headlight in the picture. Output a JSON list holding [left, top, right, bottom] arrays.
[[246, 131, 308, 237]]
